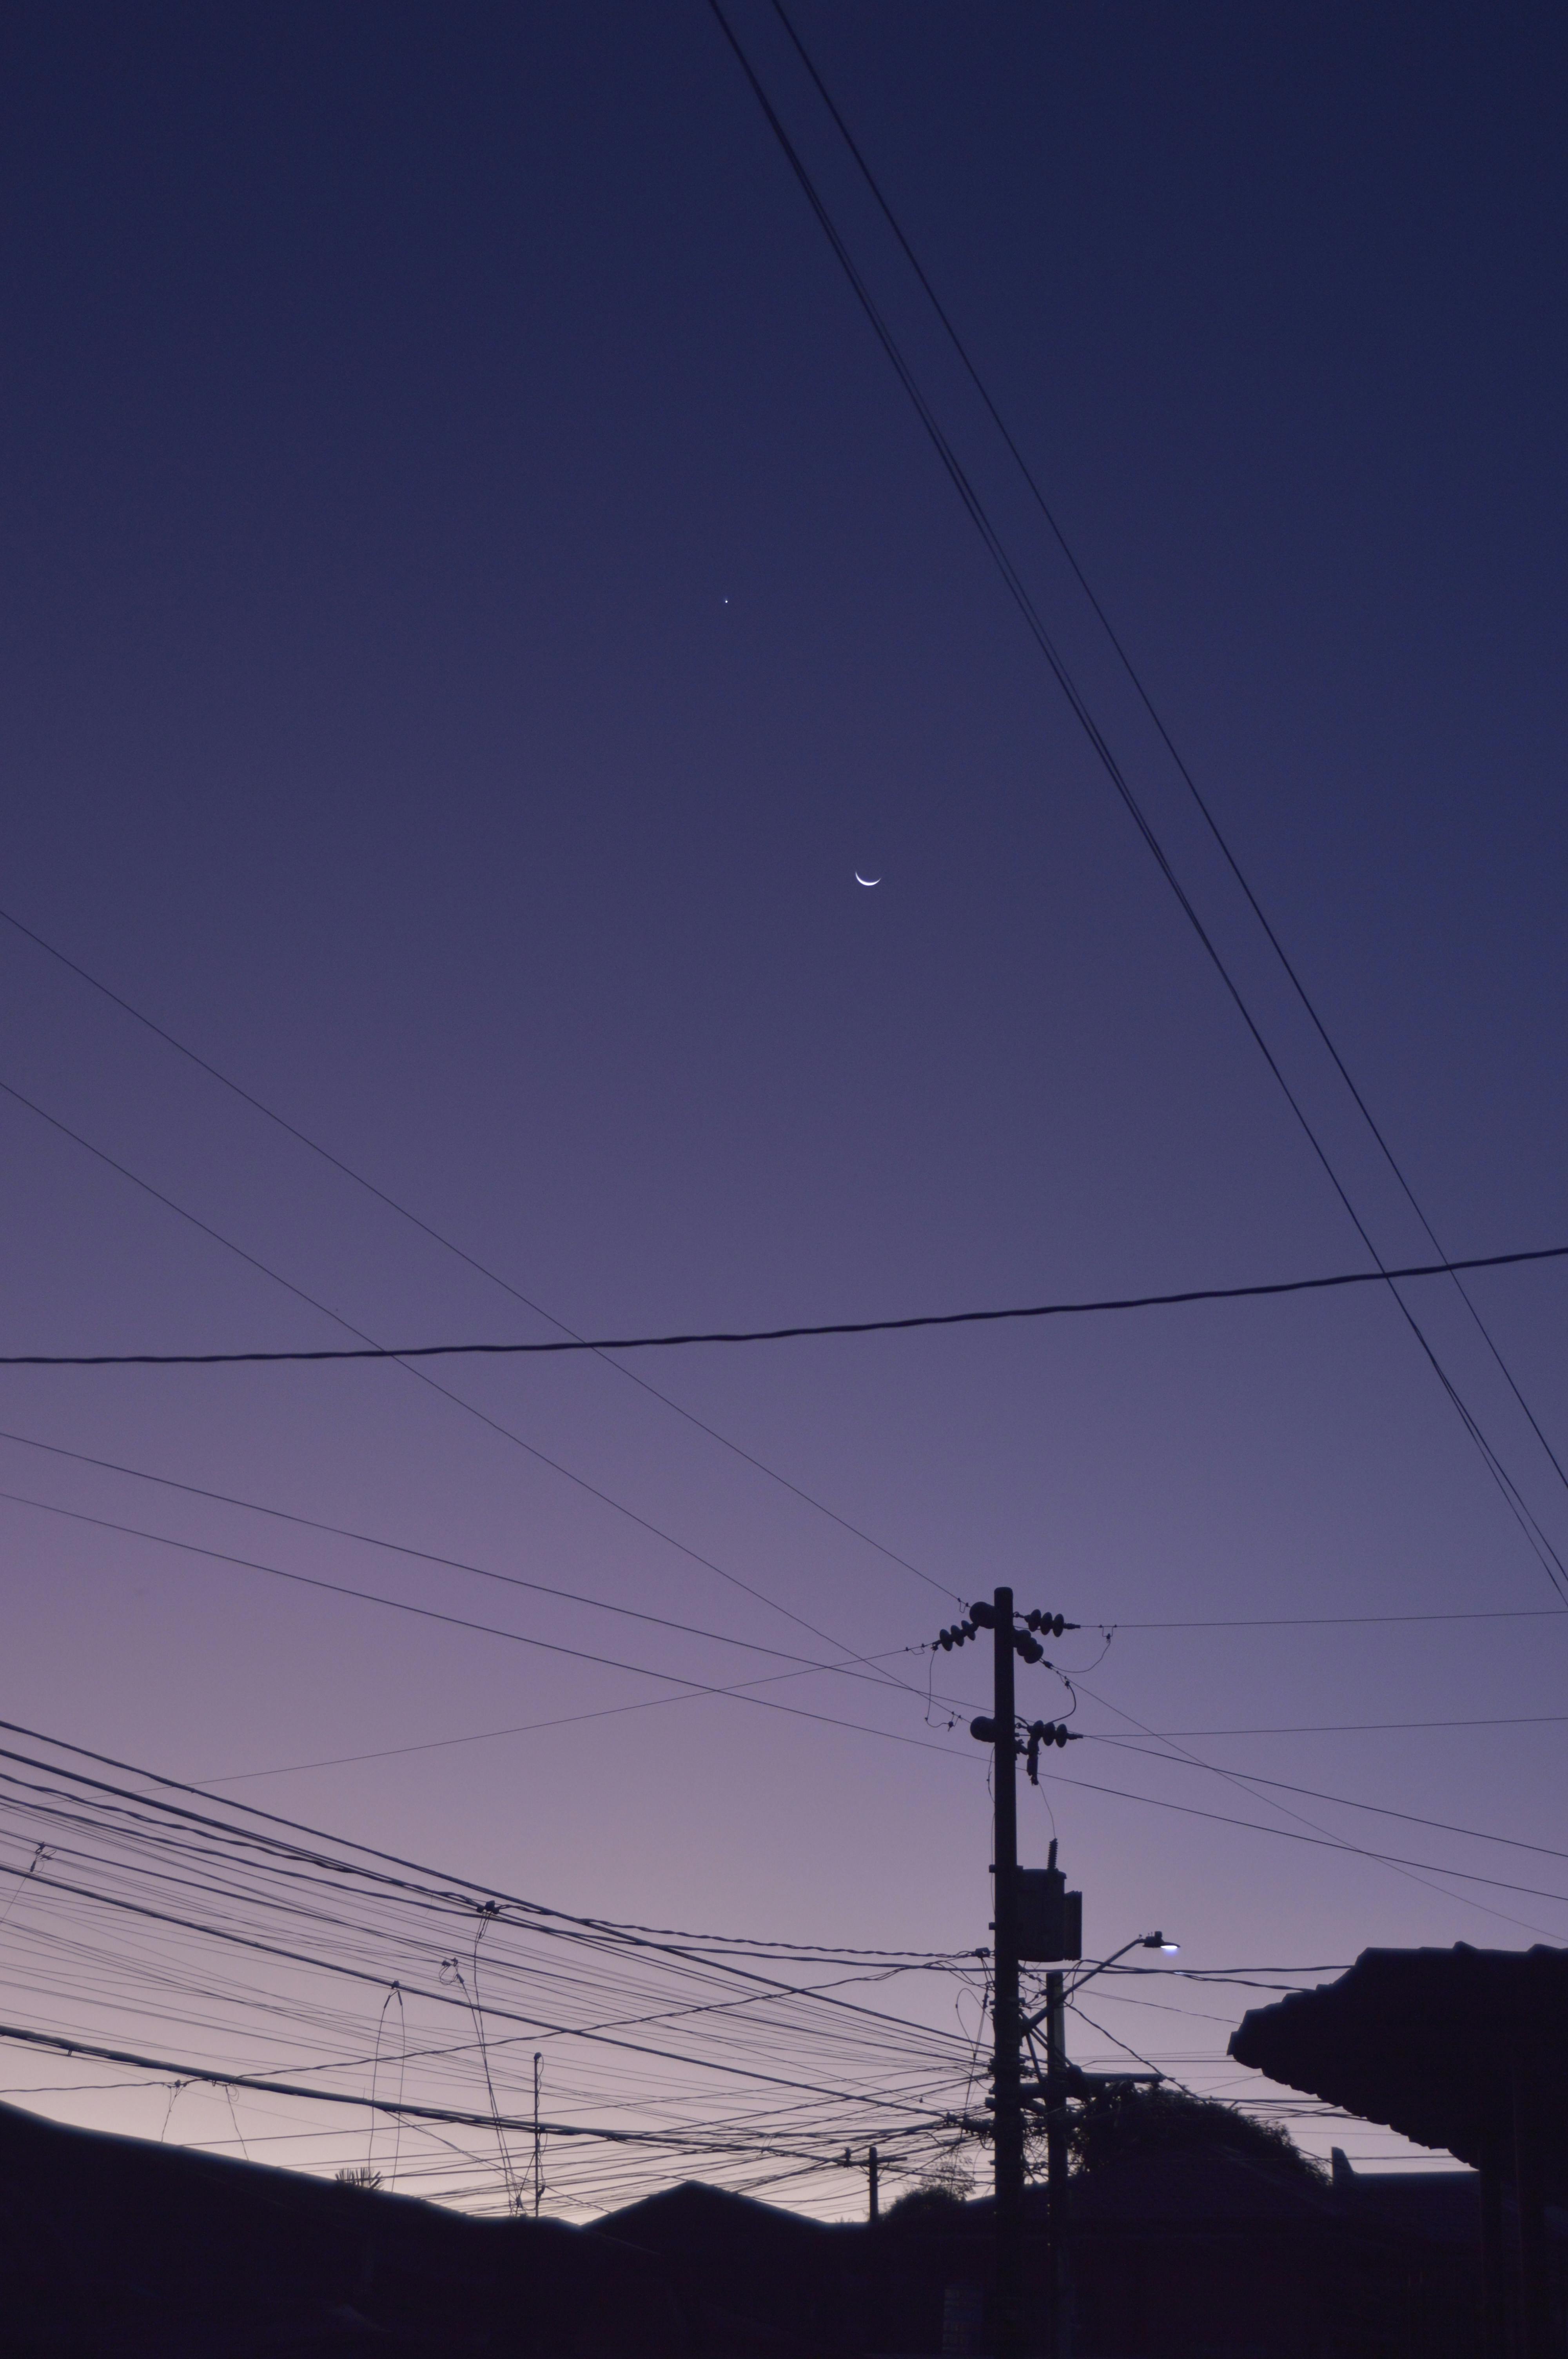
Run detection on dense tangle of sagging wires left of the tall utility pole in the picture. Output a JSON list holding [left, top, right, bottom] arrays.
[[0, 1725, 981, 2217]]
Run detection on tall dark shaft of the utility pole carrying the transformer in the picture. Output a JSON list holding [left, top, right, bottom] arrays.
[[990, 1590, 1024, 2359]]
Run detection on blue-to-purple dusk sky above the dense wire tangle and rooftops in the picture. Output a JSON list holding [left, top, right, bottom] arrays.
[[0, 0, 1568, 2203]]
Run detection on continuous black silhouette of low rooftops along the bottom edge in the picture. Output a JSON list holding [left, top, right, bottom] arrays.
[[0, 2106, 1537, 2359]]
